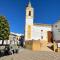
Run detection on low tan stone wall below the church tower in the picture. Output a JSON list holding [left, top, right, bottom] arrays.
[[25, 40, 48, 51]]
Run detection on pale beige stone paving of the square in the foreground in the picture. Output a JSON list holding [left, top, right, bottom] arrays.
[[0, 48, 60, 60]]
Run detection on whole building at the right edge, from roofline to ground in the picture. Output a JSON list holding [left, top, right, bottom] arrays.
[[52, 20, 60, 52]]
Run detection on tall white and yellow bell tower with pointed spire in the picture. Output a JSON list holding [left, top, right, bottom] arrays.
[[25, 1, 34, 40]]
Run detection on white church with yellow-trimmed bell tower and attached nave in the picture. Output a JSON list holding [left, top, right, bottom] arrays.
[[25, 2, 52, 42]]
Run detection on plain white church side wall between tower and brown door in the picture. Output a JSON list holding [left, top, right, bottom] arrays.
[[32, 26, 52, 40]]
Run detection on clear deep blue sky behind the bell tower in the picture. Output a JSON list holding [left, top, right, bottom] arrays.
[[0, 0, 60, 33]]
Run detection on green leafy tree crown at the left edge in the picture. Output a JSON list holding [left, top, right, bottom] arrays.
[[0, 16, 10, 40]]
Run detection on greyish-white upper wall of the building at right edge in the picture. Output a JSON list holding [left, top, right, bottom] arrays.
[[52, 21, 60, 40]]
